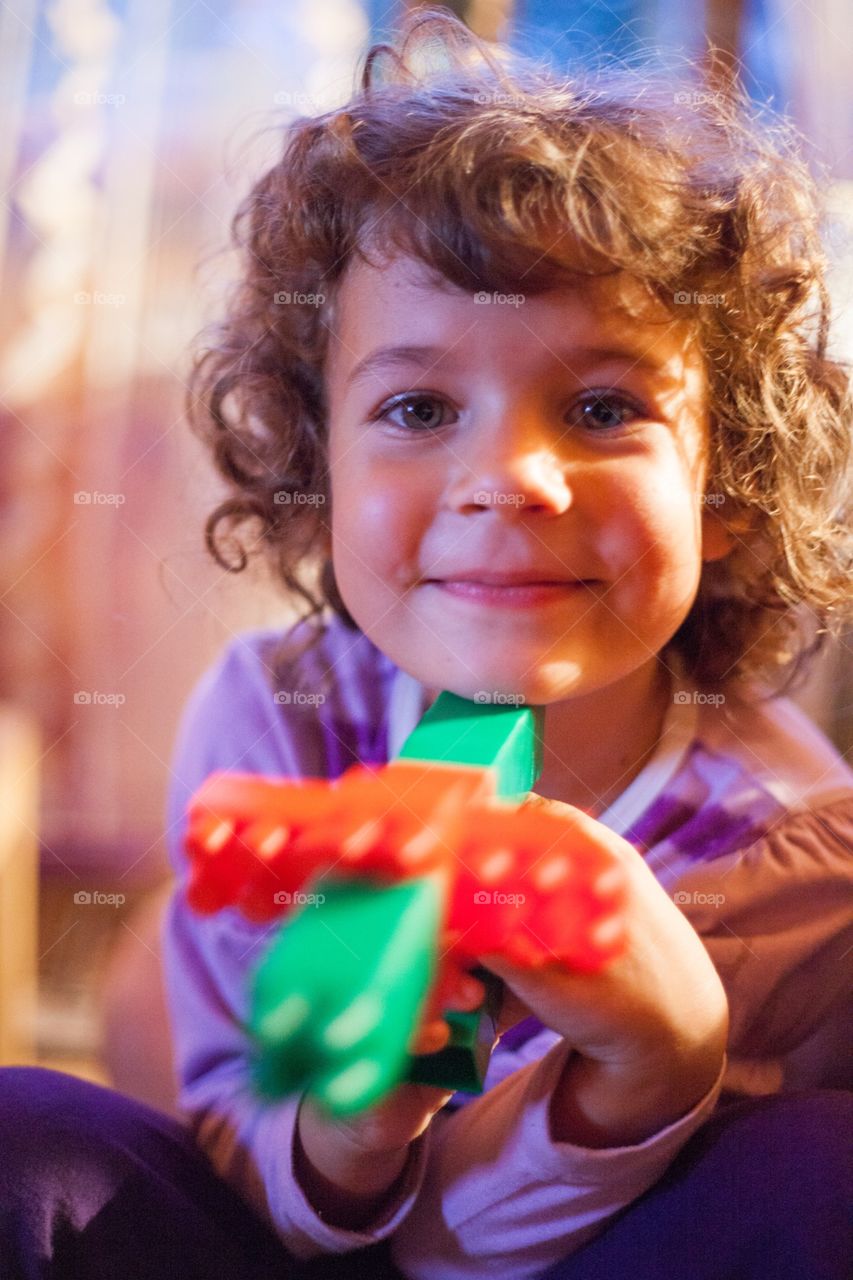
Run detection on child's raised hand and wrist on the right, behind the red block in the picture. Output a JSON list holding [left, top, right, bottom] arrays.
[[478, 796, 727, 1146]]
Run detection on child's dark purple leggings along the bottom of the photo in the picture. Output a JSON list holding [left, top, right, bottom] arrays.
[[0, 1066, 853, 1280]]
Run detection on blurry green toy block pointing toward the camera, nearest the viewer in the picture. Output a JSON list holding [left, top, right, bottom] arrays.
[[251, 877, 442, 1115]]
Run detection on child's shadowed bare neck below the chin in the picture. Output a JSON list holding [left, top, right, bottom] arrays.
[[534, 660, 672, 818]]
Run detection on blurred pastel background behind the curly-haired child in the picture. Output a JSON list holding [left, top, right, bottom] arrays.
[[0, 0, 853, 1110]]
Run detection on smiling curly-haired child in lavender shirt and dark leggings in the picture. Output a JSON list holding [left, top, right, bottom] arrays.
[[0, 10, 853, 1280]]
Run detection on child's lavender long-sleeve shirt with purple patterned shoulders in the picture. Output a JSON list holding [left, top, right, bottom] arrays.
[[164, 620, 853, 1280]]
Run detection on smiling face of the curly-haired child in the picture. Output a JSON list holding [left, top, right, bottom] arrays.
[[327, 257, 729, 704]]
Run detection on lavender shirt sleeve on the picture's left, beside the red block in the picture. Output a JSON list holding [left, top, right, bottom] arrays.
[[156, 636, 430, 1258]]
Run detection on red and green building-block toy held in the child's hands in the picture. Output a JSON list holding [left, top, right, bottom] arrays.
[[186, 692, 624, 1115]]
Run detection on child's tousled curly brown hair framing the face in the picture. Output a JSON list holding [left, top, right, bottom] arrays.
[[190, 5, 853, 691]]
